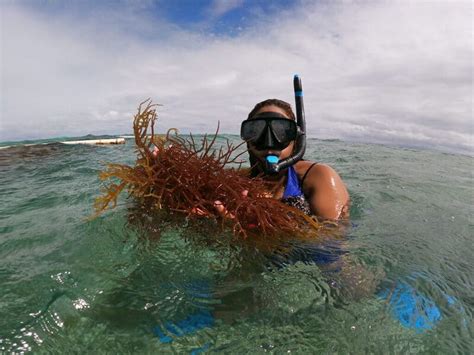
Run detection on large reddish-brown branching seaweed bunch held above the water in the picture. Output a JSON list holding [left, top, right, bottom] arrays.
[[94, 100, 323, 239]]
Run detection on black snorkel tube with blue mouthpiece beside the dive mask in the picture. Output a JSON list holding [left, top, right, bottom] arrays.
[[265, 75, 306, 175]]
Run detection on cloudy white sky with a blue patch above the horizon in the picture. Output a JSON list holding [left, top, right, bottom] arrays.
[[0, 0, 474, 155]]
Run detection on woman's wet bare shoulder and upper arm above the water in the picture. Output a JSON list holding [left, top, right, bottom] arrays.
[[295, 161, 349, 219]]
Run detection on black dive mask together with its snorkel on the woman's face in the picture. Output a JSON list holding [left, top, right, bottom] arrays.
[[240, 75, 306, 175]]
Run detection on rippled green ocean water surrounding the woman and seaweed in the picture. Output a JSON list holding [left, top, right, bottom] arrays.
[[0, 136, 474, 354]]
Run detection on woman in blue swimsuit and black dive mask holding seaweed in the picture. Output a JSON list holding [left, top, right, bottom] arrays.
[[215, 99, 349, 220]]
